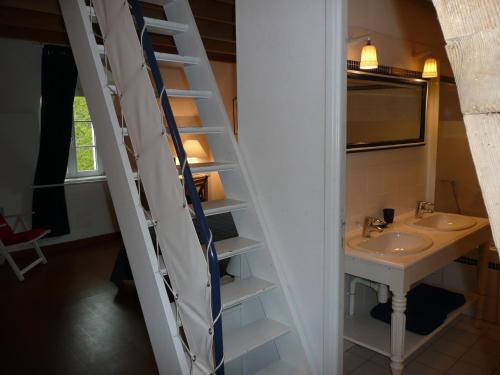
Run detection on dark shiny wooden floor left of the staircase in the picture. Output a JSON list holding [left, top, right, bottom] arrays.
[[0, 239, 158, 375]]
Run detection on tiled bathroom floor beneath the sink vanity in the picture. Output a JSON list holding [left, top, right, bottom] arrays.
[[344, 316, 500, 375]]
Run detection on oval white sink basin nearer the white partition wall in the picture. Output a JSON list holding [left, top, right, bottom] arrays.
[[347, 232, 433, 256]]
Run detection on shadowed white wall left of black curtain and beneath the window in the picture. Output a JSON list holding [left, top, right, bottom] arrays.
[[0, 39, 118, 243]]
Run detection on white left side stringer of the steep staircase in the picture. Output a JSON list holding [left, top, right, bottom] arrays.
[[59, 0, 190, 375]]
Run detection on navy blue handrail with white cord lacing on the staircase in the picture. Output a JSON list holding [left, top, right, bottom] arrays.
[[129, 0, 224, 375]]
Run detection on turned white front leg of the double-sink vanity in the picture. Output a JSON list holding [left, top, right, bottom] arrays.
[[391, 294, 406, 375]]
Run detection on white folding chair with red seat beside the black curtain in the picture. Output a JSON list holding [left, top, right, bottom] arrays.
[[0, 215, 50, 281]]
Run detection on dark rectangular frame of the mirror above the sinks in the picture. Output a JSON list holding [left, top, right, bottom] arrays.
[[346, 70, 429, 153]]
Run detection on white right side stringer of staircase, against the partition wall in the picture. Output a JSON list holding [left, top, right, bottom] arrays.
[[163, 0, 313, 371]]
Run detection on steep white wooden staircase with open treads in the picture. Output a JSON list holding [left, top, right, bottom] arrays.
[[60, 0, 309, 375]]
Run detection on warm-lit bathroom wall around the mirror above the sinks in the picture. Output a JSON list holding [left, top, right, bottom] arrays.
[[347, 0, 444, 230]]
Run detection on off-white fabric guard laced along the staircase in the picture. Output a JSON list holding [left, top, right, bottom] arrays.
[[94, 0, 213, 374]]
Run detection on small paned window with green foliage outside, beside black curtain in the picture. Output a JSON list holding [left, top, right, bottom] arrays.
[[66, 96, 104, 178]]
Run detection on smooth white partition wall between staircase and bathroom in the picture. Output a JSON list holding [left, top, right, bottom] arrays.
[[236, 0, 343, 373]]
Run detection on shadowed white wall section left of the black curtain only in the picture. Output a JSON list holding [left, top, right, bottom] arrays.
[[0, 39, 42, 219]]
